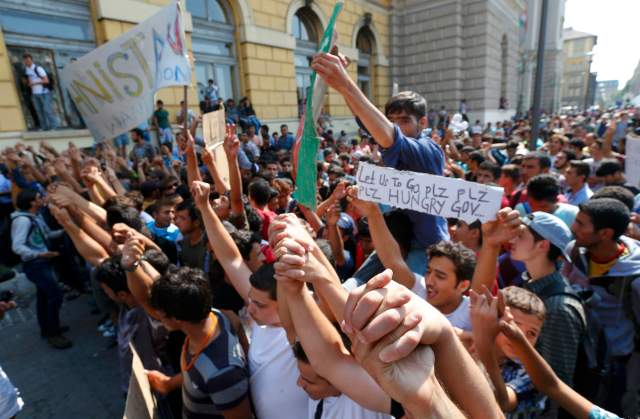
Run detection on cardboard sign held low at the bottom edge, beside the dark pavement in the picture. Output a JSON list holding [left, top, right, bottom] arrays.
[[123, 344, 158, 419]]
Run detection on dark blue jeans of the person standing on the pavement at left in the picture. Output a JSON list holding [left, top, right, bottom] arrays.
[[22, 259, 62, 336]]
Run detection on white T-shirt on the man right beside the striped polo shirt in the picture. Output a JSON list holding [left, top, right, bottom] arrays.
[[249, 323, 309, 419]]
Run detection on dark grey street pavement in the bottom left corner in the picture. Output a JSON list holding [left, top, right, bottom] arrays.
[[0, 295, 124, 419]]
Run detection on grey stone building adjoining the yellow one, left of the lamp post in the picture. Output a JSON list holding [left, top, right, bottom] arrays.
[[390, 0, 526, 122]]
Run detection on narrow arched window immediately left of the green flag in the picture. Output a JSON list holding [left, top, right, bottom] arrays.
[[292, 7, 321, 114]]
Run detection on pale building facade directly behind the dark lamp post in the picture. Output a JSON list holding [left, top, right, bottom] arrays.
[[516, 0, 565, 114]]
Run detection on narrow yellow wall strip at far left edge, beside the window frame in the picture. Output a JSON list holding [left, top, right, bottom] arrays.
[[0, 30, 26, 131]]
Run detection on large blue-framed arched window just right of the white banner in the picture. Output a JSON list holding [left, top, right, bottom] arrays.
[[187, 0, 239, 101]]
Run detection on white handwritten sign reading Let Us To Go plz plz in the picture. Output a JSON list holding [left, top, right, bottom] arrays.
[[357, 163, 503, 223]]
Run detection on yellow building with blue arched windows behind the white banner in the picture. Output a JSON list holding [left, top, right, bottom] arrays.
[[0, 0, 391, 146]]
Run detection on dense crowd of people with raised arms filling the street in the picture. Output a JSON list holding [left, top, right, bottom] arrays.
[[0, 50, 640, 419]]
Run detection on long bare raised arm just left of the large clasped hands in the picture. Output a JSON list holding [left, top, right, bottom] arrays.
[[191, 182, 251, 304]]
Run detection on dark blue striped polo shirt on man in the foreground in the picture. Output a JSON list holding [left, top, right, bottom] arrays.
[[182, 310, 249, 419]]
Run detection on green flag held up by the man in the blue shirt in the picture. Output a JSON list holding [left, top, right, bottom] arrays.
[[294, 0, 344, 210]]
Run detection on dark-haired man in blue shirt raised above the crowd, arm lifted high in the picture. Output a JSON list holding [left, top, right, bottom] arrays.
[[311, 54, 449, 274]]
